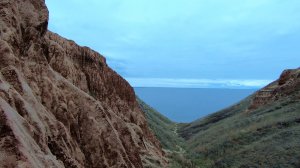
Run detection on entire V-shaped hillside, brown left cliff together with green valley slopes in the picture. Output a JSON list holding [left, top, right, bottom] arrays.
[[0, 0, 300, 168]]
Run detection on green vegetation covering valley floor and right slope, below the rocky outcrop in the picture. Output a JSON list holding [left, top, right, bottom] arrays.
[[139, 84, 300, 168]]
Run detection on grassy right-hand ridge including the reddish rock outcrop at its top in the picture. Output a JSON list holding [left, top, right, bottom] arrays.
[[179, 69, 300, 167]]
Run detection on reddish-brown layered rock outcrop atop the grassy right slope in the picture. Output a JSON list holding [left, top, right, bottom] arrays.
[[249, 68, 300, 110]]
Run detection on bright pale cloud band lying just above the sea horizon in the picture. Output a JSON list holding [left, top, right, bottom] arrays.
[[126, 78, 272, 88]]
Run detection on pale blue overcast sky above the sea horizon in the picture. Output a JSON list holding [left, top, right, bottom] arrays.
[[46, 0, 300, 88]]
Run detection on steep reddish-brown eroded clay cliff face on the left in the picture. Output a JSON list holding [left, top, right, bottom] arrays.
[[0, 0, 166, 168]]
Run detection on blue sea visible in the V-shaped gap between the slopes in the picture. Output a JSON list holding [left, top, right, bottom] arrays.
[[134, 87, 256, 122]]
